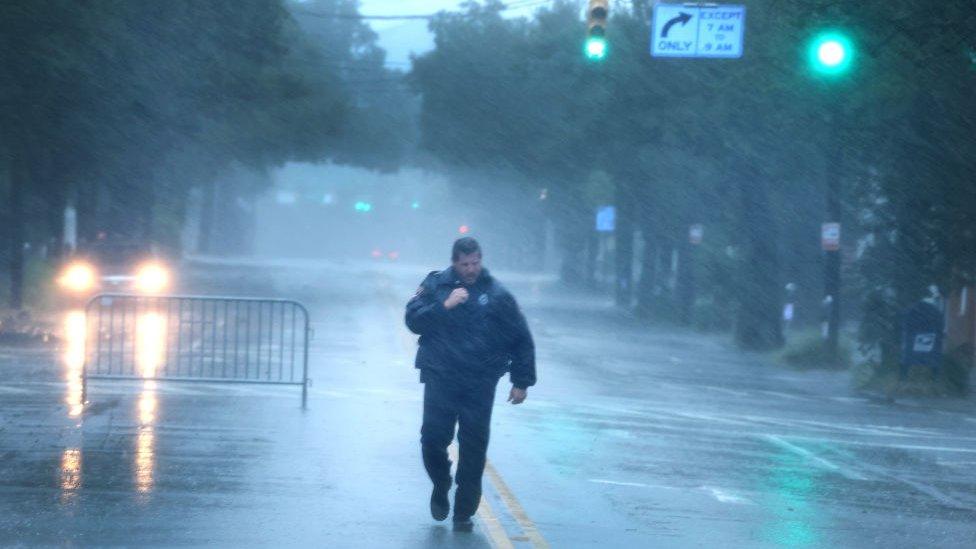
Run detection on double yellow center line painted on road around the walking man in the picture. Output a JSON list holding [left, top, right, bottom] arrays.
[[387, 274, 549, 549]]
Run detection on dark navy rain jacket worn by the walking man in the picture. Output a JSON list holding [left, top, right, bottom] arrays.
[[406, 268, 535, 389]]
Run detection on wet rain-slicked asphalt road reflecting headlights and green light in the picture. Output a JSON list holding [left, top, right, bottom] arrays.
[[0, 262, 976, 547]]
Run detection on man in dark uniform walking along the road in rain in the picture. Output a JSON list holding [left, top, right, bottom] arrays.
[[406, 237, 535, 531]]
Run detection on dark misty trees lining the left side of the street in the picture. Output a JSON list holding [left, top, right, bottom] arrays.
[[0, 0, 399, 306]]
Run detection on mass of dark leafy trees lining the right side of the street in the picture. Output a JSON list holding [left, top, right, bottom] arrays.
[[411, 0, 976, 354]]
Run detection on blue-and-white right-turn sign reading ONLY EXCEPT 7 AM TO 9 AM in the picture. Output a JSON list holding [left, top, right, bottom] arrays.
[[651, 4, 746, 59]]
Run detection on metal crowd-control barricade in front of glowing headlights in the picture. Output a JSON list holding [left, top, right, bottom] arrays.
[[82, 294, 309, 408]]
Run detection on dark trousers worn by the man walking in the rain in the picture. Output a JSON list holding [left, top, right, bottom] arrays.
[[420, 375, 498, 518]]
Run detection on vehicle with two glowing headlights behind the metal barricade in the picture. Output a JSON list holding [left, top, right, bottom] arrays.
[[57, 239, 172, 300]]
